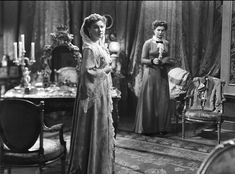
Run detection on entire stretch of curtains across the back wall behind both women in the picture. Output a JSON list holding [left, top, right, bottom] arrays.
[[0, 1, 222, 118]]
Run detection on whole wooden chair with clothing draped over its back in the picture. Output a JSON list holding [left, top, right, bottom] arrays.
[[182, 76, 224, 143]]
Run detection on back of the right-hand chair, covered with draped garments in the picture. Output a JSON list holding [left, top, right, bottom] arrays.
[[186, 76, 224, 112]]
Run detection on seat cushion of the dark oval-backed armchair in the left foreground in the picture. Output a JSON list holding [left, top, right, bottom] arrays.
[[4, 138, 65, 165]]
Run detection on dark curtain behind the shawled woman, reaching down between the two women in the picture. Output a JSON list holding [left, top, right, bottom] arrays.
[[69, 1, 141, 118]]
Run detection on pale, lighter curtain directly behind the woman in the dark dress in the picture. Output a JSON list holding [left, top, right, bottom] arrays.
[[129, 1, 181, 96]]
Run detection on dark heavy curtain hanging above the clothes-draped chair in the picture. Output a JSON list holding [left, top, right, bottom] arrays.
[[180, 1, 222, 76]]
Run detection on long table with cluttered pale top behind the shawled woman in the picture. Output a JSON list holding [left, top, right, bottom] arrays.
[[1, 85, 121, 135]]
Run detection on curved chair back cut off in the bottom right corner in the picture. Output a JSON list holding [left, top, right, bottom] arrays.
[[197, 139, 235, 174]]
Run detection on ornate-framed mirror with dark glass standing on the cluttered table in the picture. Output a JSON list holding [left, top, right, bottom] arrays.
[[41, 25, 81, 82]]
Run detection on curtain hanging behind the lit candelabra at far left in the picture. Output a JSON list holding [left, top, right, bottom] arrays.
[[1, 1, 69, 70]]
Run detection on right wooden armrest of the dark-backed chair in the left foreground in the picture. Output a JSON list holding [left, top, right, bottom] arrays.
[[43, 123, 66, 145]]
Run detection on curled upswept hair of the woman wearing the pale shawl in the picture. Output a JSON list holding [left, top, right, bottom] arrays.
[[83, 13, 107, 37]]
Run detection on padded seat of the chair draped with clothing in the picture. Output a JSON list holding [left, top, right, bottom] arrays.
[[185, 109, 221, 121]]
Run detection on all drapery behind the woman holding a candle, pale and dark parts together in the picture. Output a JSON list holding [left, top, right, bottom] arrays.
[[129, 1, 222, 96]]
